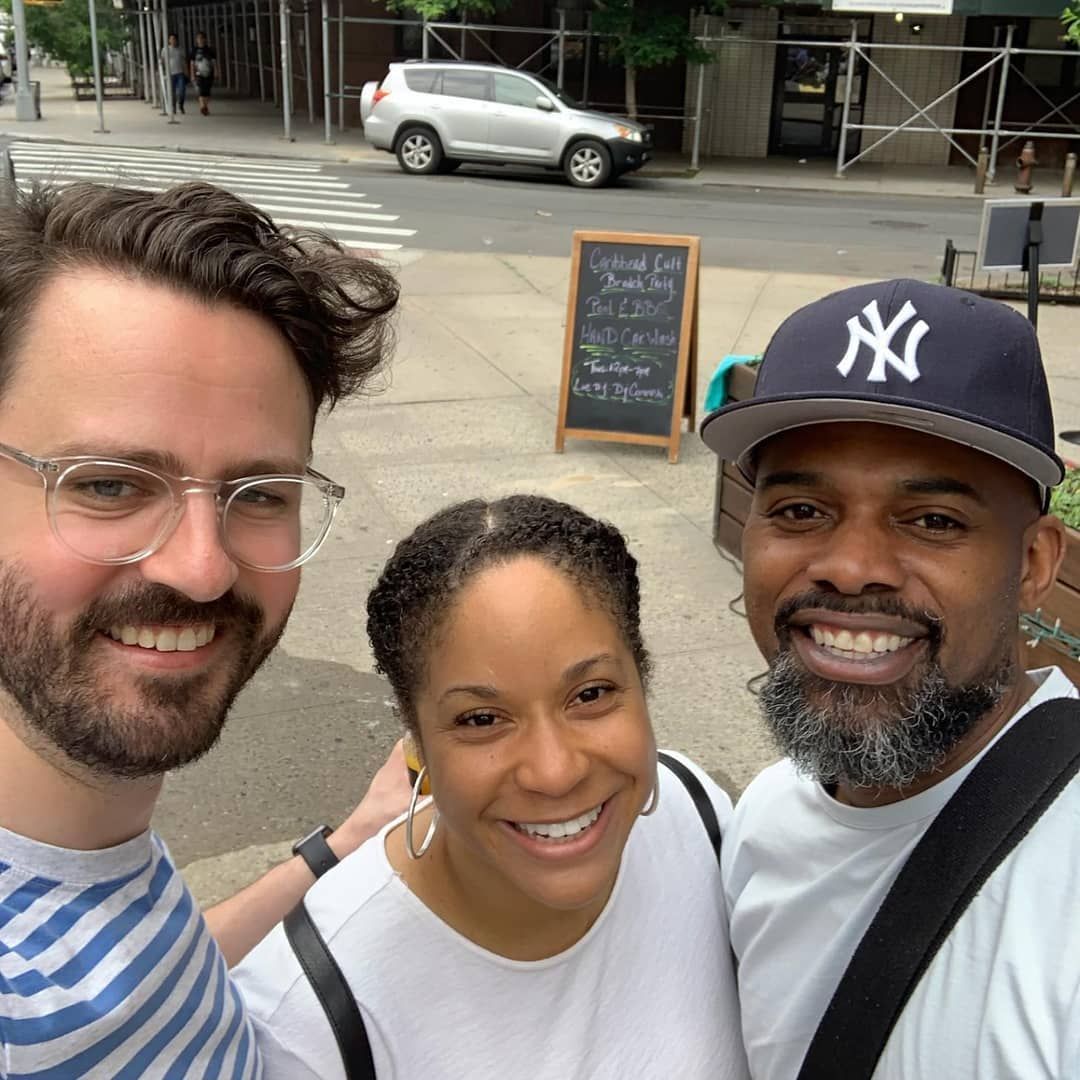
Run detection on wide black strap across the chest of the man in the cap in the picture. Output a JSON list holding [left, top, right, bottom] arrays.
[[798, 698, 1080, 1080]]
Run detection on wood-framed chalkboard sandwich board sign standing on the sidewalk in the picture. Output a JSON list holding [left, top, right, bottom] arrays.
[[555, 232, 701, 462]]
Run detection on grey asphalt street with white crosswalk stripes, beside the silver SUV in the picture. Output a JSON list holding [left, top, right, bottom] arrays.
[[13, 141, 981, 279]]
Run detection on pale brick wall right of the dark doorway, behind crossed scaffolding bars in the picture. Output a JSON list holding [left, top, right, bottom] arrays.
[[856, 15, 966, 167]]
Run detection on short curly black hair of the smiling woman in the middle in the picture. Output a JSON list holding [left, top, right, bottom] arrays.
[[367, 495, 650, 734]]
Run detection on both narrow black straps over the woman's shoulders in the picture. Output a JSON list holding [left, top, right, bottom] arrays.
[[284, 752, 720, 1080]]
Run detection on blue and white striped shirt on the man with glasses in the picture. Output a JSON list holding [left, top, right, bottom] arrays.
[[0, 828, 261, 1080]]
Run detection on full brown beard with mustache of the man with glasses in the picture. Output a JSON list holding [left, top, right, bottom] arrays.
[[0, 565, 288, 780]]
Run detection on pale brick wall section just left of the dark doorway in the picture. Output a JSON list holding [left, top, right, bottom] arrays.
[[683, 8, 778, 158]]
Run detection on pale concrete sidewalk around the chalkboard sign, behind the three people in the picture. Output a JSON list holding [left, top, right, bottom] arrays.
[[157, 250, 1080, 901]]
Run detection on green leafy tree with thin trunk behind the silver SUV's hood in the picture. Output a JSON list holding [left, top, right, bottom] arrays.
[[593, 0, 725, 119]]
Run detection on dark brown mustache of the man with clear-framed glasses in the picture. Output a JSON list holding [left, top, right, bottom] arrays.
[[72, 583, 264, 639]]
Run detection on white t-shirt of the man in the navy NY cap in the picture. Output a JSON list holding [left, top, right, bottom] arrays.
[[724, 667, 1080, 1080]]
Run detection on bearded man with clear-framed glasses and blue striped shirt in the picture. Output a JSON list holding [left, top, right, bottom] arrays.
[[0, 184, 406, 1080]]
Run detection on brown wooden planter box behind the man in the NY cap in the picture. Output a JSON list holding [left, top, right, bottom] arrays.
[[713, 364, 1080, 685]]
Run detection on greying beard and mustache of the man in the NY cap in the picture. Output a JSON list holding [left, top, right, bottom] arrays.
[[760, 596, 1016, 788]]
